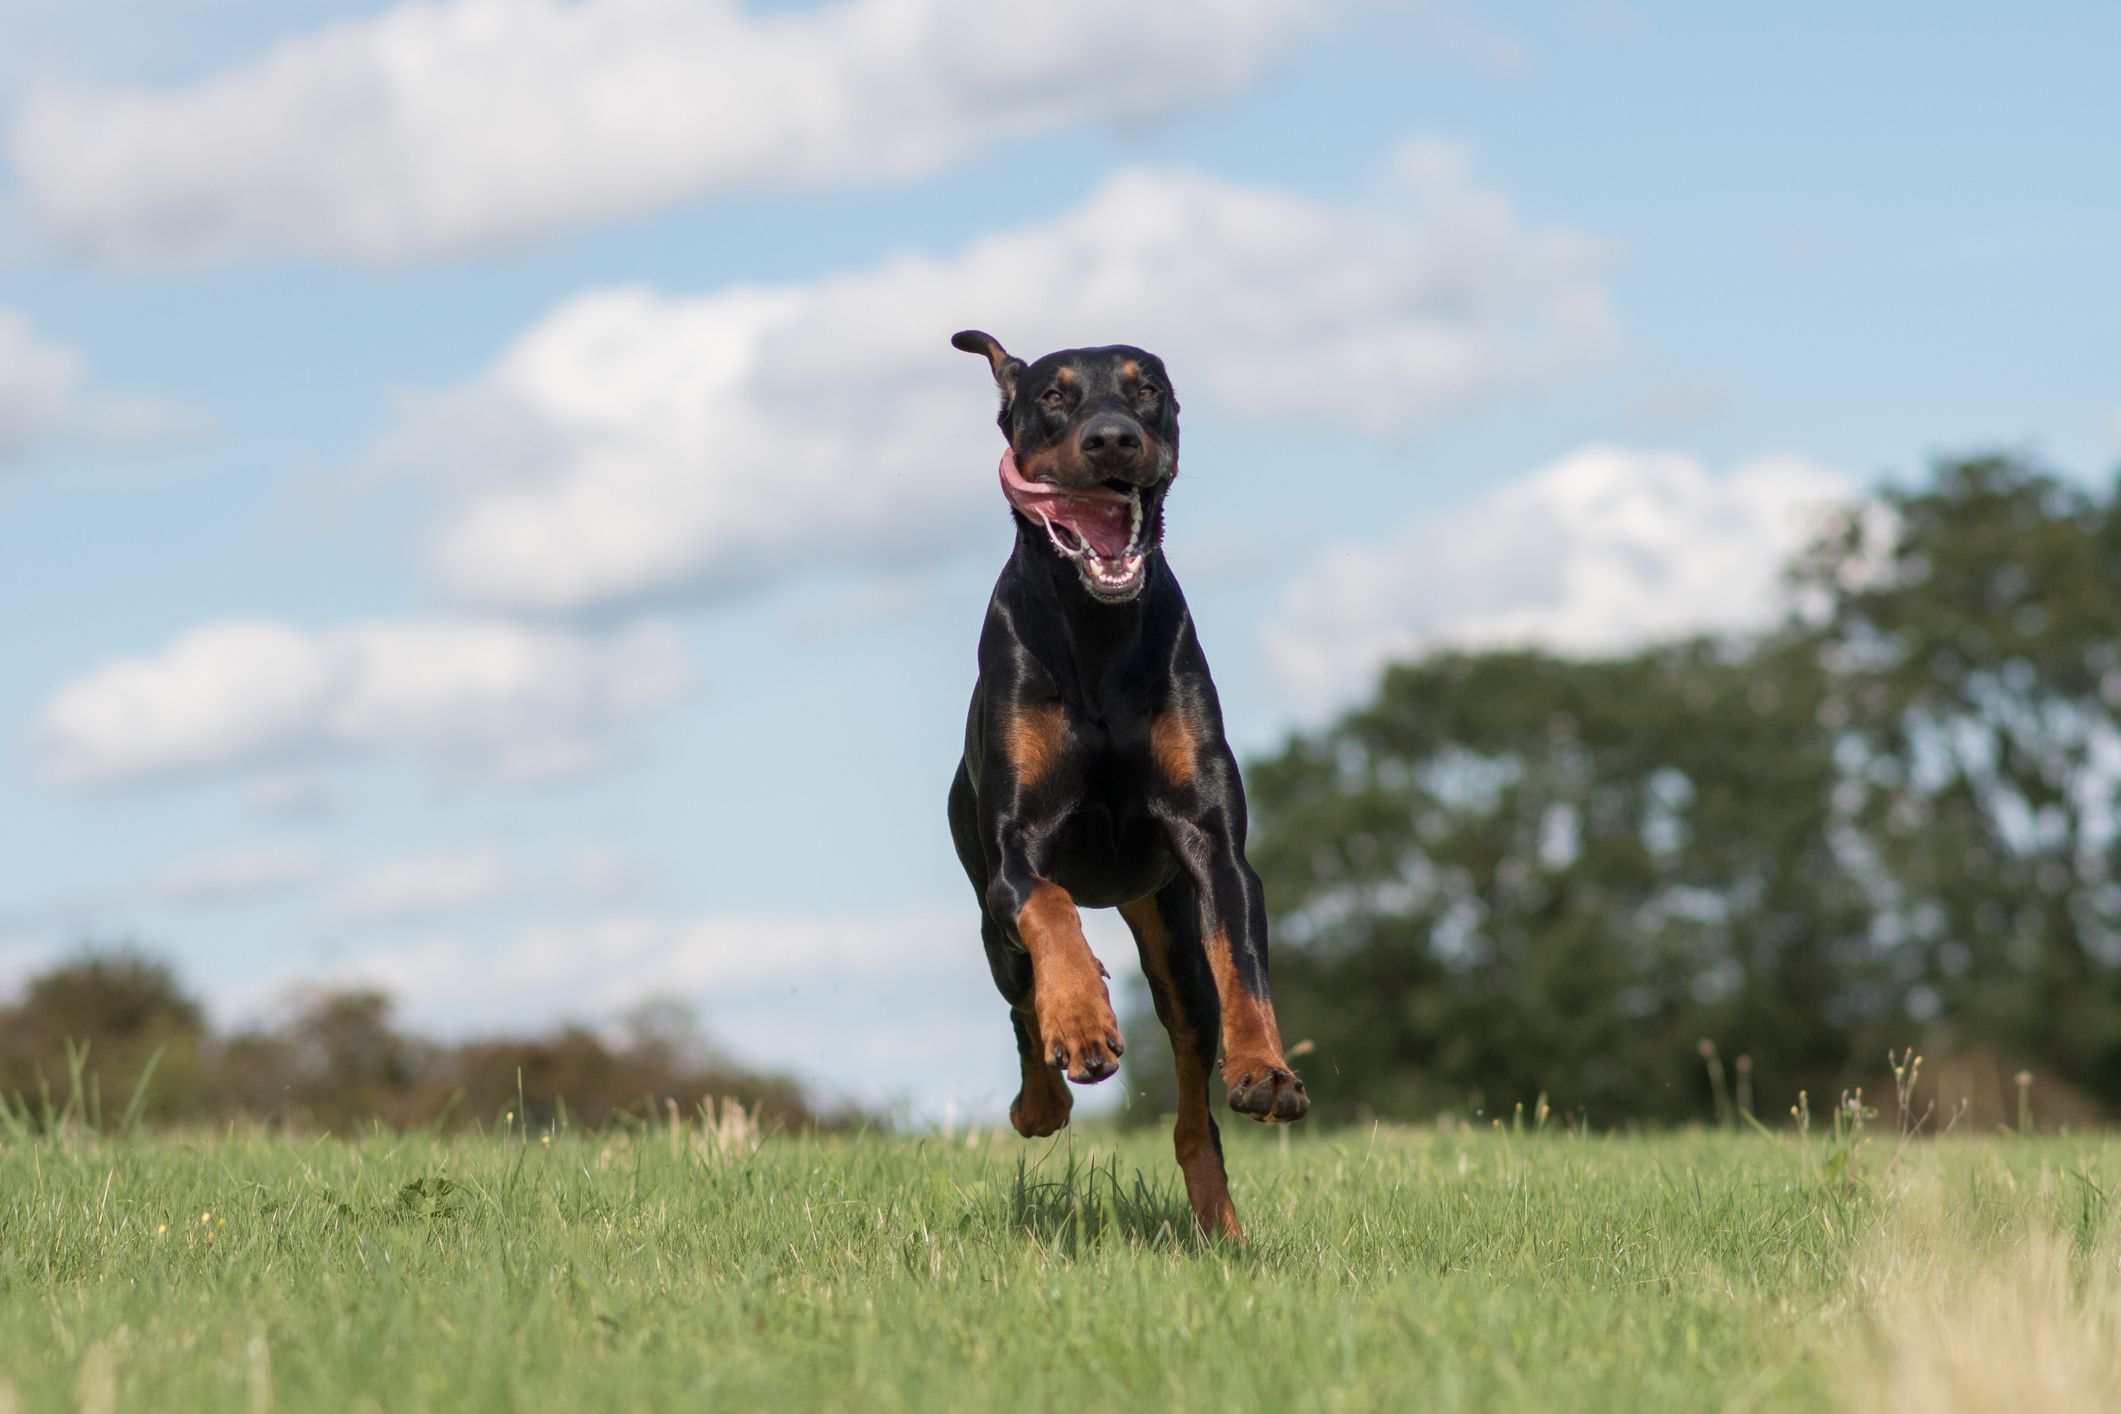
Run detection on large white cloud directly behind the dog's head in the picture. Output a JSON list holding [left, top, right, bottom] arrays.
[[375, 140, 1614, 611]]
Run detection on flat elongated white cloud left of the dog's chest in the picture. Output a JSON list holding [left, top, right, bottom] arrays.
[[36, 617, 687, 784]]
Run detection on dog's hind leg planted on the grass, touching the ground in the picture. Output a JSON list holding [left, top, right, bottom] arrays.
[[1120, 873, 1245, 1240]]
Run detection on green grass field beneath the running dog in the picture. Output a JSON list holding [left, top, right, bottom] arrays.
[[0, 1121, 2121, 1414]]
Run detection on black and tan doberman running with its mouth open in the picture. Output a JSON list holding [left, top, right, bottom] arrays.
[[950, 329, 1311, 1238]]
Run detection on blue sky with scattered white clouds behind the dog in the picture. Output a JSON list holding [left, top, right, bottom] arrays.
[[0, 0, 2121, 1119]]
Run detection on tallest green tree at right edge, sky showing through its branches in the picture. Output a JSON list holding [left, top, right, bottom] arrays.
[[1799, 456, 2121, 1104]]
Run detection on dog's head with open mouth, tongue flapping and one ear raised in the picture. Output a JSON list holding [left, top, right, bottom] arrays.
[[950, 329, 1179, 604]]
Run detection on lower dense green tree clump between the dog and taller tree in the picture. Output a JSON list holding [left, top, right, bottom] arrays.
[[1254, 638, 1864, 1121]]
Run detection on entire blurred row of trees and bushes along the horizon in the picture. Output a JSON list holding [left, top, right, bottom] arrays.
[[0, 456, 2121, 1132]]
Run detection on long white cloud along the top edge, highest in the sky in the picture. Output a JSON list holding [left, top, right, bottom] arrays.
[[11, 0, 1330, 263]]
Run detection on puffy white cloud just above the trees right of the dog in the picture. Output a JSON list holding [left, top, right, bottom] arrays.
[[1266, 447, 1856, 708]]
